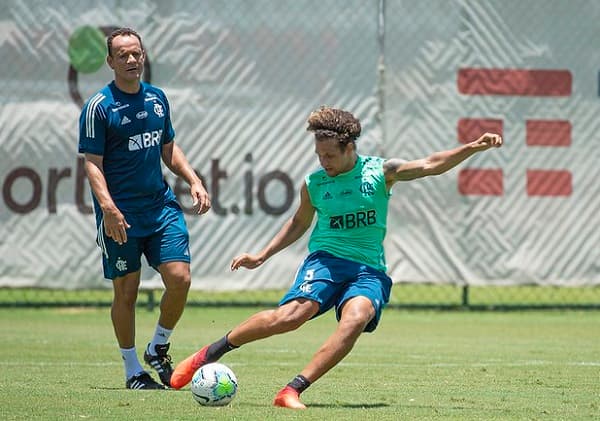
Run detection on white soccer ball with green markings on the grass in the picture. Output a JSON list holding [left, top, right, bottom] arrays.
[[190, 363, 237, 406]]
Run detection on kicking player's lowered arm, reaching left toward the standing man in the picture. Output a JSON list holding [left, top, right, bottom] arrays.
[[231, 183, 315, 270]]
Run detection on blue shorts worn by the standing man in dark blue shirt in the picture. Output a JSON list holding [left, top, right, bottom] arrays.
[[96, 202, 190, 279]]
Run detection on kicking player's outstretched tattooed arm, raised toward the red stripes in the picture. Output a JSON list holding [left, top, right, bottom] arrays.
[[383, 133, 502, 188]]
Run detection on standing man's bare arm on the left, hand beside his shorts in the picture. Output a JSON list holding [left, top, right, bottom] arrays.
[[85, 153, 130, 244]]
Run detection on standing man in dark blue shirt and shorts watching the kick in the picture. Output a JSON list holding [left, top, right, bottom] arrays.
[[79, 28, 210, 389]]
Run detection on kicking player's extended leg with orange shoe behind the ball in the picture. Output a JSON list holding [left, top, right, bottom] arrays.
[[171, 299, 319, 389]]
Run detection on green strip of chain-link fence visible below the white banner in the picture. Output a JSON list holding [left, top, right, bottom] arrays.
[[0, 284, 600, 310]]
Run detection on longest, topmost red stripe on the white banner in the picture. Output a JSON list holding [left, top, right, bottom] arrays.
[[457, 68, 573, 96]]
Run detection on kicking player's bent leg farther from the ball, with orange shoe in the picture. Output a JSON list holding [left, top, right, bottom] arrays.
[[273, 297, 375, 409]]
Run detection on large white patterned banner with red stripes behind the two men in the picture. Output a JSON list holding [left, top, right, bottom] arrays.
[[0, 0, 600, 290]]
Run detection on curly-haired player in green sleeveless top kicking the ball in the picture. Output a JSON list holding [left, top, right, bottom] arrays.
[[171, 107, 502, 409]]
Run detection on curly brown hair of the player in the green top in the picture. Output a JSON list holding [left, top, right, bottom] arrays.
[[306, 106, 361, 147]]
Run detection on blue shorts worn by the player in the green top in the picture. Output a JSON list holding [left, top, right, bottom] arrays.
[[279, 251, 392, 332]]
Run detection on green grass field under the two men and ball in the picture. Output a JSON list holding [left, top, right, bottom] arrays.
[[0, 308, 600, 421]]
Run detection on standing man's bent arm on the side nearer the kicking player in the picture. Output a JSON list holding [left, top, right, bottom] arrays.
[[162, 141, 210, 214]]
